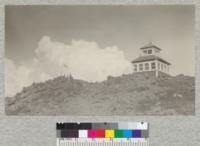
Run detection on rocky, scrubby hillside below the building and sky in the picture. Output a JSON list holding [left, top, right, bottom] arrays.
[[5, 72, 195, 115]]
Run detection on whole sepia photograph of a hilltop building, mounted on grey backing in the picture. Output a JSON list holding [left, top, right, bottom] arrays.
[[4, 5, 195, 116]]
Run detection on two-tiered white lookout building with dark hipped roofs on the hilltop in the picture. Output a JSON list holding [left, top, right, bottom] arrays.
[[132, 42, 171, 77]]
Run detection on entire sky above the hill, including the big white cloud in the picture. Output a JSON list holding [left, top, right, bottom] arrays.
[[5, 5, 195, 96]]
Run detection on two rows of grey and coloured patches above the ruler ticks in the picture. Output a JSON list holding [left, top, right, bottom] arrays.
[[56, 122, 149, 140]]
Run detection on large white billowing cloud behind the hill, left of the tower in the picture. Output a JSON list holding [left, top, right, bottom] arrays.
[[6, 36, 132, 96]]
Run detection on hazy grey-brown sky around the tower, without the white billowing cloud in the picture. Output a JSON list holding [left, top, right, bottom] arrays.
[[5, 5, 195, 96]]
